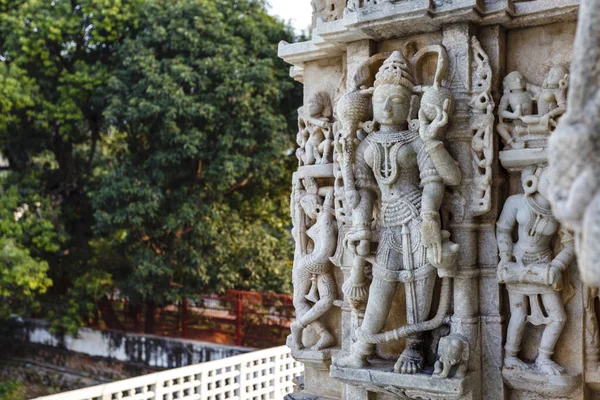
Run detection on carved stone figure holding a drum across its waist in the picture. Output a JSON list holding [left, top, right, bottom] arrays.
[[496, 167, 575, 375]]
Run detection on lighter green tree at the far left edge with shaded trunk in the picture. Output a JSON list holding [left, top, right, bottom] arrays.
[[0, 0, 141, 330]]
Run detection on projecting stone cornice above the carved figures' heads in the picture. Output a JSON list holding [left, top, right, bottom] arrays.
[[279, 0, 579, 65]]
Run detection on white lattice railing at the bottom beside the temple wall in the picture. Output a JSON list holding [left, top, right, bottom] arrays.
[[34, 346, 304, 400]]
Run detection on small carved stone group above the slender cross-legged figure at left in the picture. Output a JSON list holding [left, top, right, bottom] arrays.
[[296, 92, 333, 166]]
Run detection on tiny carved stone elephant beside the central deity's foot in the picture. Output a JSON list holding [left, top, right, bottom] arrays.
[[433, 334, 469, 378]]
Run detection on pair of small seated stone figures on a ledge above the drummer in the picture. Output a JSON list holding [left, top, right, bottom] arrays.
[[497, 66, 569, 149]]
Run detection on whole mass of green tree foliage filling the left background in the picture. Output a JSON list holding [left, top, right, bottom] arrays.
[[0, 0, 302, 336]]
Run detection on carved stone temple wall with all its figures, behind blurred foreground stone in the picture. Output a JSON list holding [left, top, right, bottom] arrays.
[[279, 0, 600, 400]]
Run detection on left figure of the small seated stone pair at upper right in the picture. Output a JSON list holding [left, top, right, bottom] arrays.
[[496, 71, 535, 148]]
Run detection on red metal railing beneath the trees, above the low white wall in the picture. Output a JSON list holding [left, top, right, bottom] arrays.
[[90, 290, 294, 348]]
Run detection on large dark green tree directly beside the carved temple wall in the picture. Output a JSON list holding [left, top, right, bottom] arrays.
[[92, 0, 300, 329]]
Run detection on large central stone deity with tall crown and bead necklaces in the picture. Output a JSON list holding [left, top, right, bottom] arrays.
[[335, 51, 460, 374]]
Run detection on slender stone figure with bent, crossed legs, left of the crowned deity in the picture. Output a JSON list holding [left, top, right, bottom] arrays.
[[290, 177, 337, 350]]
